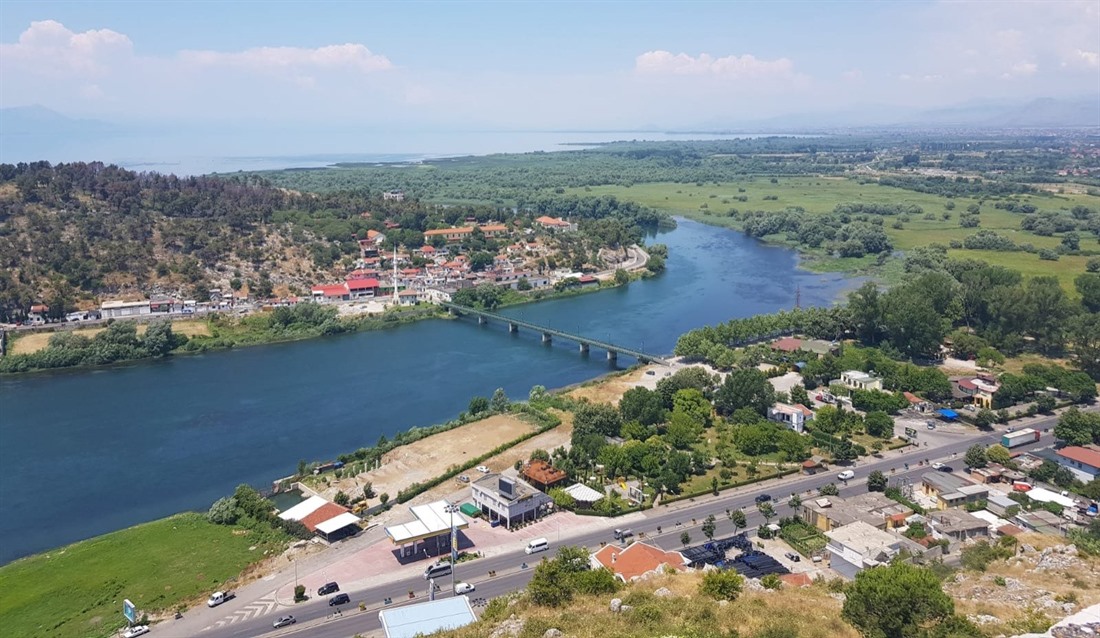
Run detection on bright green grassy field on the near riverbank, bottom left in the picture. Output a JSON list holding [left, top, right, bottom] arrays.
[[0, 514, 281, 638]]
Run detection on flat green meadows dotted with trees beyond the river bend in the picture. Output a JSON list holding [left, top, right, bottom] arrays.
[[569, 177, 1100, 294]]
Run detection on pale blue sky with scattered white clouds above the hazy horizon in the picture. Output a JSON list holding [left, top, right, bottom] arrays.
[[0, 0, 1100, 145]]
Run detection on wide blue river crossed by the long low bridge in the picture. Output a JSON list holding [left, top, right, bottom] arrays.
[[0, 220, 854, 563]]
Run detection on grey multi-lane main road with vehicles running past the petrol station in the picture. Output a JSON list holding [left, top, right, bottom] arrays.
[[184, 416, 1078, 638]]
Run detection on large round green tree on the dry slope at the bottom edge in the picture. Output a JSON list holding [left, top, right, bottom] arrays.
[[840, 562, 955, 638]]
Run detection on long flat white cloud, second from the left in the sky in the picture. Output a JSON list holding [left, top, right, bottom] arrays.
[[179, 43, 393, 73]]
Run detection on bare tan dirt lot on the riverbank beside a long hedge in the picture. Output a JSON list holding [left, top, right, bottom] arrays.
[[310, 415, 547, 505]]
